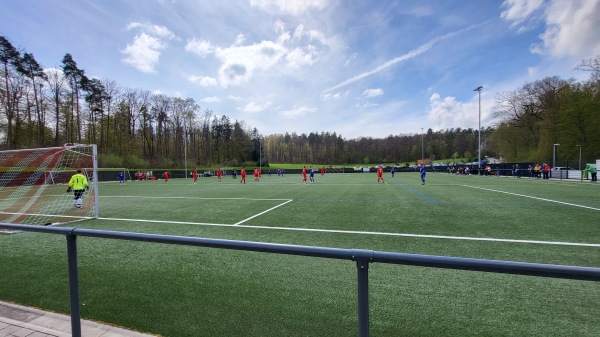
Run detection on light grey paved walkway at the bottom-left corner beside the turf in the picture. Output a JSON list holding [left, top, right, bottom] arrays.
[[0, 302, 156, 337]]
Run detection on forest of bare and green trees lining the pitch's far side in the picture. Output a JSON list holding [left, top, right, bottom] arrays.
[[0, 36, 600, 169]]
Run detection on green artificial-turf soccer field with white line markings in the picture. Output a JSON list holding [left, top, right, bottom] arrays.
[[0, 173, 600, 337]]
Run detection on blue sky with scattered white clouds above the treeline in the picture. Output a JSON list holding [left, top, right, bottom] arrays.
[[0, 0, 600, 139]]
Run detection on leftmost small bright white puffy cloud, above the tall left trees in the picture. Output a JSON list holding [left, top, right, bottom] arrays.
[[121, 33, 164, 73]]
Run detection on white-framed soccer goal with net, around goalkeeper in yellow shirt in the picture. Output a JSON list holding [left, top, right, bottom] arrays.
[[0, 144, 99, 225]]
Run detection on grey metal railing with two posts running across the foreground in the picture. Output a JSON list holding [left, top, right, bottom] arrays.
[[0, 223, 600, 337]]
